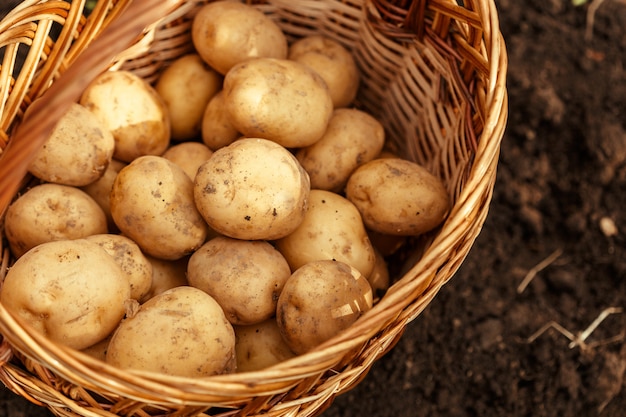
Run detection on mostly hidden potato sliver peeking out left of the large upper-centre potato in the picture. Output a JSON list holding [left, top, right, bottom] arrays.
[[202, 91, 241, 151]]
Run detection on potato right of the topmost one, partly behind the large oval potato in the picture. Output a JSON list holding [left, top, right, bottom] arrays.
[[288, 35, 360, 108]]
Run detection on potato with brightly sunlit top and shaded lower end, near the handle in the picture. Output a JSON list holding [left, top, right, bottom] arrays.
[[80, 71, 170, 162]]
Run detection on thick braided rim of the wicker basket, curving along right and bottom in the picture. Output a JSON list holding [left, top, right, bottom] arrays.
[[0, 0, 508, 405]]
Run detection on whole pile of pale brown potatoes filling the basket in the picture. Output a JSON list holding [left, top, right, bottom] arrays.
[[0, 1, 449, 377]]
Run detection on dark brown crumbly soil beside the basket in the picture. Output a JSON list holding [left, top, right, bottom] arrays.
[[0, 0, 626, 417]]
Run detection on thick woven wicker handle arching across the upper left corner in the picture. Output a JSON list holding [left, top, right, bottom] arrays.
[[0, 0, 182, 217]]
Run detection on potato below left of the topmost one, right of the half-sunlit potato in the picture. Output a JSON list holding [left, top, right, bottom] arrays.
[[154, 54, 222, 141]]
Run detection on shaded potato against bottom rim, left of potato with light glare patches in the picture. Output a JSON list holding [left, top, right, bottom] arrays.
[[234, 318, 295, 372]]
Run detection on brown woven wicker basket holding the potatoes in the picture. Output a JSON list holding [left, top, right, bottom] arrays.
[[0, 0, 507, 416]]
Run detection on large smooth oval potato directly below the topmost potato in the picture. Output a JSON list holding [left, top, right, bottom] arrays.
[[223, 58, 333, 148]]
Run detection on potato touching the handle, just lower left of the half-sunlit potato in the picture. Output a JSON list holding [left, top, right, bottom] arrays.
[[29, 103, 115, 187]]
